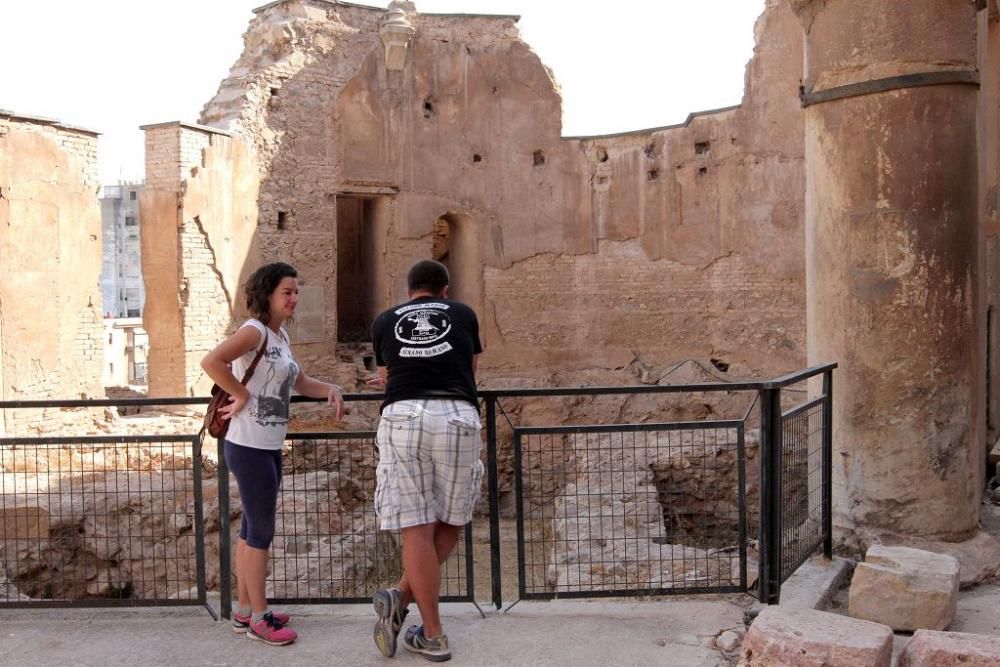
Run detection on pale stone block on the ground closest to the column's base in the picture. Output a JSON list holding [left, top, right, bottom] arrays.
[[848, 545, 959, 631]]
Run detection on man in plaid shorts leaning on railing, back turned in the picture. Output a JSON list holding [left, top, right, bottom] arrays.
[[372, 260, 483, 662]]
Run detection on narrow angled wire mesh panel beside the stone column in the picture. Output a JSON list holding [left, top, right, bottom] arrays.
[[780, 397, 824, 581]]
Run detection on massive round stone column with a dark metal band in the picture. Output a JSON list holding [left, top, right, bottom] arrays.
[[788, 0, 985, 540]]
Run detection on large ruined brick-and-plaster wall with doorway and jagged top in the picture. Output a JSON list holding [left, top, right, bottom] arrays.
[[166, 0, 805, 392]]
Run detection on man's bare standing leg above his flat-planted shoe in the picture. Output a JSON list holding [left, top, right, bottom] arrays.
[[400, 522, 458, 637]]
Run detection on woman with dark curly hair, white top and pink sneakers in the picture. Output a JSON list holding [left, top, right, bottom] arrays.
[[201, 262, 344, 646]]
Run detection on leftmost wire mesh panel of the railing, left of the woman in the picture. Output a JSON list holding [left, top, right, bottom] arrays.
[[0, 436, 206, 607]]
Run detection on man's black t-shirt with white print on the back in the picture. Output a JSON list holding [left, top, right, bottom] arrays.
[[372, 296, 483, 408]]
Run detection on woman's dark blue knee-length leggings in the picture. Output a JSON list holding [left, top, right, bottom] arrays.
[[224, 440, 281, 549]]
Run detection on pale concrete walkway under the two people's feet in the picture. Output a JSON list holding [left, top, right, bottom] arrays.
[[0, 596, 750, 667]]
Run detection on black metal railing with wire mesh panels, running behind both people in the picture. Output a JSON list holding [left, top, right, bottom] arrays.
[[0, 364, 836, 617]]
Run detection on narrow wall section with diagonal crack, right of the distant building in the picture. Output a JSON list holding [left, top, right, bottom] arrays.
[[139, 123, 258, 396]]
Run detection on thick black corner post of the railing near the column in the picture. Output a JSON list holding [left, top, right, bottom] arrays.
[[758, 388, 782, 604]]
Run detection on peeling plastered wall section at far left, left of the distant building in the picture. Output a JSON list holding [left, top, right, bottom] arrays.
[[0, 111, 104, 434]]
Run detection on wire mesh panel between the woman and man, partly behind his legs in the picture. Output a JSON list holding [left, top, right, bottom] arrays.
[[258, 432, 474, 604]]
